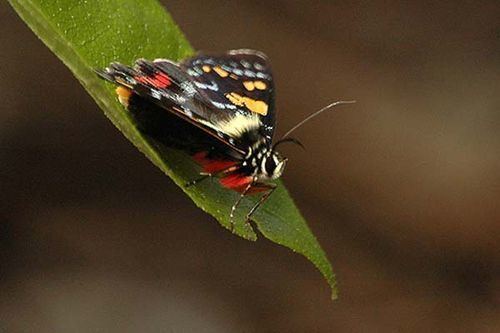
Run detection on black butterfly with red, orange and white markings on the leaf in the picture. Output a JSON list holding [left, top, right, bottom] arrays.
[[96, 49, 352, 229]]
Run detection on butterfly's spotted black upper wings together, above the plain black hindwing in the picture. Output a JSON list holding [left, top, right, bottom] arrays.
[[98, 50, 274, 154]]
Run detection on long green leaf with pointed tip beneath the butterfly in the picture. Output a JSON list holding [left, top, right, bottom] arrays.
[[9, 0, 336, 298]]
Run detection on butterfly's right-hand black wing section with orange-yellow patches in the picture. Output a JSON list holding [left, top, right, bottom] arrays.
[[181, 49, 275, 143]]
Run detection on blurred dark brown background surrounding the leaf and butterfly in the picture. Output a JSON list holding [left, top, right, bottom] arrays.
[[0, 0, 500, 332]]
